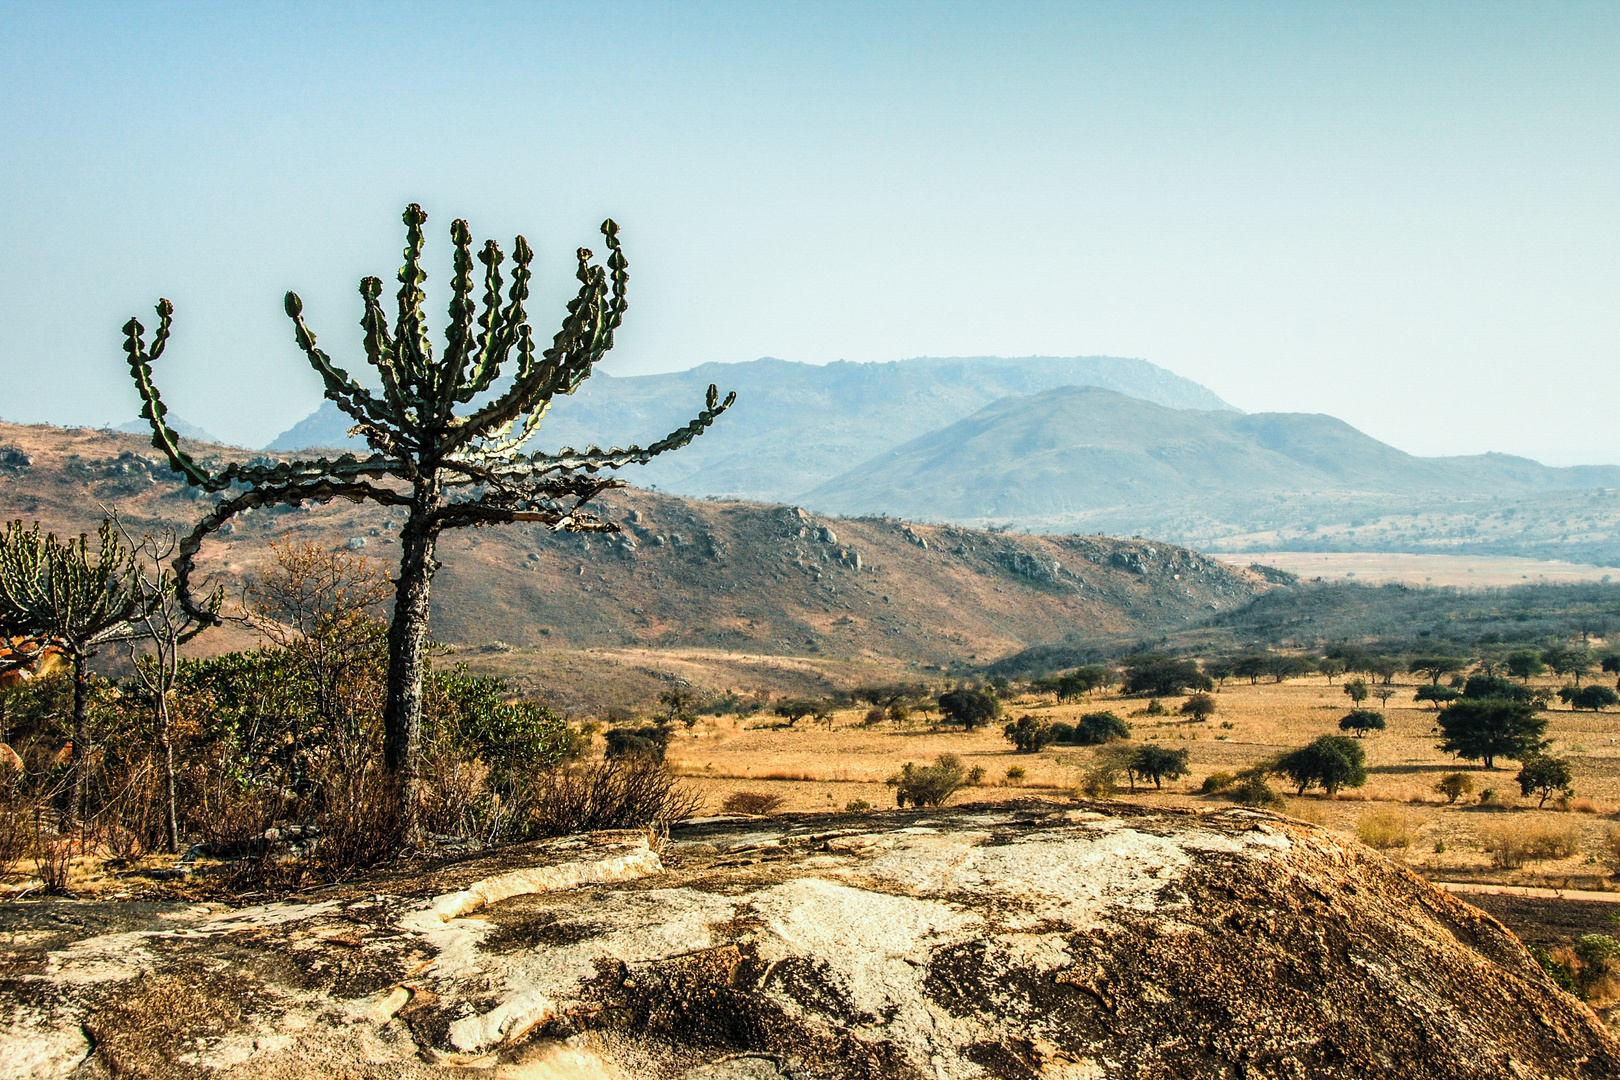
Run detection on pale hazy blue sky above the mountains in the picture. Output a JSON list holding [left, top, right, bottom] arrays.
[[0, 3, 1620, 463]]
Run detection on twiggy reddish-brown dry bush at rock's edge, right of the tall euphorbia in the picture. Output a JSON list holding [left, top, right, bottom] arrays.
[[528, 755, 703, 837]]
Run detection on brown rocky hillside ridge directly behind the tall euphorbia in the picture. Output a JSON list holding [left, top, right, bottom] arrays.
[[0, 424, 1275, 664]]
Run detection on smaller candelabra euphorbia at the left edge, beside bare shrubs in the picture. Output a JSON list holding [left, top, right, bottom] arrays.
[[0, 520, 159, 824]]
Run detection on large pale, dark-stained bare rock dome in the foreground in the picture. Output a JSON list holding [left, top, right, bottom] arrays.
[[0, 803, 1620, 1080]]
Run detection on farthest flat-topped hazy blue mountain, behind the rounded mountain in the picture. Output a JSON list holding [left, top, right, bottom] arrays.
[[269, 356, 1231, 500]]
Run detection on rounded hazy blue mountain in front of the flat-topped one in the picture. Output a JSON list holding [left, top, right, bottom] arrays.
[[804, 387, 1620, 557]]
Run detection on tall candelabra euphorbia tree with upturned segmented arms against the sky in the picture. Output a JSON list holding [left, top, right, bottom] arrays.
[[123, 204, 735, 814]]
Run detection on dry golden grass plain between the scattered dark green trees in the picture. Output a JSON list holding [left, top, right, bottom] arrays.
[[651, 677, 1620, 889]]
